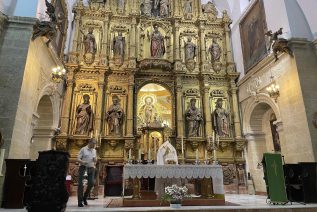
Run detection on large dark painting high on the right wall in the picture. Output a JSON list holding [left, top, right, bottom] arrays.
[[240, 0, 267, 72]]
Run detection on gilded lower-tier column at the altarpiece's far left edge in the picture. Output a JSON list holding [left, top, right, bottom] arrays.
[[61, 66, 77, 135]]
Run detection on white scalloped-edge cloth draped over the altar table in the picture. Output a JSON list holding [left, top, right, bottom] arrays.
[[123, 164, 224, 194]]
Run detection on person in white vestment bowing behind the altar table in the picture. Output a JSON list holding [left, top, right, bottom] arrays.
[[155, 140, 181, 199]]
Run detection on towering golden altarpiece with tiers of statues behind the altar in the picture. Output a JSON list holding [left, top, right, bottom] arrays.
[[56, 0, 245, 195]]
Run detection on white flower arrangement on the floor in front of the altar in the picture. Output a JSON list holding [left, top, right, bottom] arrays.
[[162, 185, 190, 203]]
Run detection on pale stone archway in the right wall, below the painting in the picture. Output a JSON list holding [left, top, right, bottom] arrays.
[[243, 94, 282, 192]]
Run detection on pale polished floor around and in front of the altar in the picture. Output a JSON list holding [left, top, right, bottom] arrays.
[[0, 194, 317, 212]]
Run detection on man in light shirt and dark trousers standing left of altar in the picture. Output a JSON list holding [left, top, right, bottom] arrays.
[[77, 138, 97, 207]]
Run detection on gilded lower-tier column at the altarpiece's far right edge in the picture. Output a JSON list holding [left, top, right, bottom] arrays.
[[229, 73, 241, 138]]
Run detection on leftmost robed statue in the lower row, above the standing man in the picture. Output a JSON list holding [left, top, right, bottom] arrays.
[[75, 94, 93, 135]]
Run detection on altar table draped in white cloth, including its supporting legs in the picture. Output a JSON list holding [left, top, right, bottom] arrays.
[[123, 164, 224, 204]]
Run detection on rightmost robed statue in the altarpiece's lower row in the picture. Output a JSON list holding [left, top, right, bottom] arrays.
[[213, 98, 229, 137]]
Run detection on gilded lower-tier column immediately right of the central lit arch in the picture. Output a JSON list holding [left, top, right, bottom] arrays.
[[176, 76, 184, 138]]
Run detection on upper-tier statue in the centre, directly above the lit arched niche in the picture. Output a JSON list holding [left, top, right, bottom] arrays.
[[147, 24, 165, 58]]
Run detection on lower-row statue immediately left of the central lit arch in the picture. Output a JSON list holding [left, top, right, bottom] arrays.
[[106, 95, 124, 135]]
